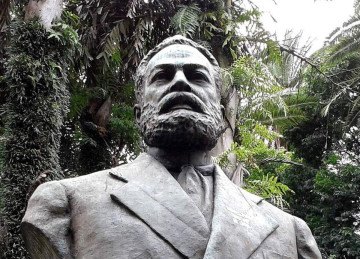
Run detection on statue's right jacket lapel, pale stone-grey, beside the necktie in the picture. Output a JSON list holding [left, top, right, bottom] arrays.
[[204, 167, 279, 259]]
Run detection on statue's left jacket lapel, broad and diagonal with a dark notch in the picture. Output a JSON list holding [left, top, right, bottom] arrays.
[[110, 154, 210, 258]]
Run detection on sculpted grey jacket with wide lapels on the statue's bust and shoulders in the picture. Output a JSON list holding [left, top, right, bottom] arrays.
[[21, 154, 321, 259]]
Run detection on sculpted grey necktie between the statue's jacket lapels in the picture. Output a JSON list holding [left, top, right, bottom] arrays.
[[177, 165, 214, 228]]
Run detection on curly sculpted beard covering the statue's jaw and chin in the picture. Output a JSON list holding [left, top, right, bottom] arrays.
[[139, 100, 224, 150]]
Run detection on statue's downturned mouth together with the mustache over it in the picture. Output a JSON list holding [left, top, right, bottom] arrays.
[[159, 93, 204, 114]]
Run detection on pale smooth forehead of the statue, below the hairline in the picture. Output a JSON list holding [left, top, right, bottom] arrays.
[[147, 44, 212, 69]]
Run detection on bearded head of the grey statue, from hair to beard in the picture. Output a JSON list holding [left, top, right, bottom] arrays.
[[135, 36, 224, 151]]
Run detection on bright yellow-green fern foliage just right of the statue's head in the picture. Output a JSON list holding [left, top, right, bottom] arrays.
[[224, 40, 317, 211]]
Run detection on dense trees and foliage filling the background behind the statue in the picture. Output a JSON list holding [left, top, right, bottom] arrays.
[[0, 0, 360, 258]]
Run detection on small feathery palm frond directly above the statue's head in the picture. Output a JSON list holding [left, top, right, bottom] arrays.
[[170, 4, 201, 38]]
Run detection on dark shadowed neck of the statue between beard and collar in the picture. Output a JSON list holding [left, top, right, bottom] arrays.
[[147, 147, 212, 172]]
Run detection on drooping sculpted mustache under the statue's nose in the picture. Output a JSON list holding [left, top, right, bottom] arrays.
[[158, 92, 206, 113]]
